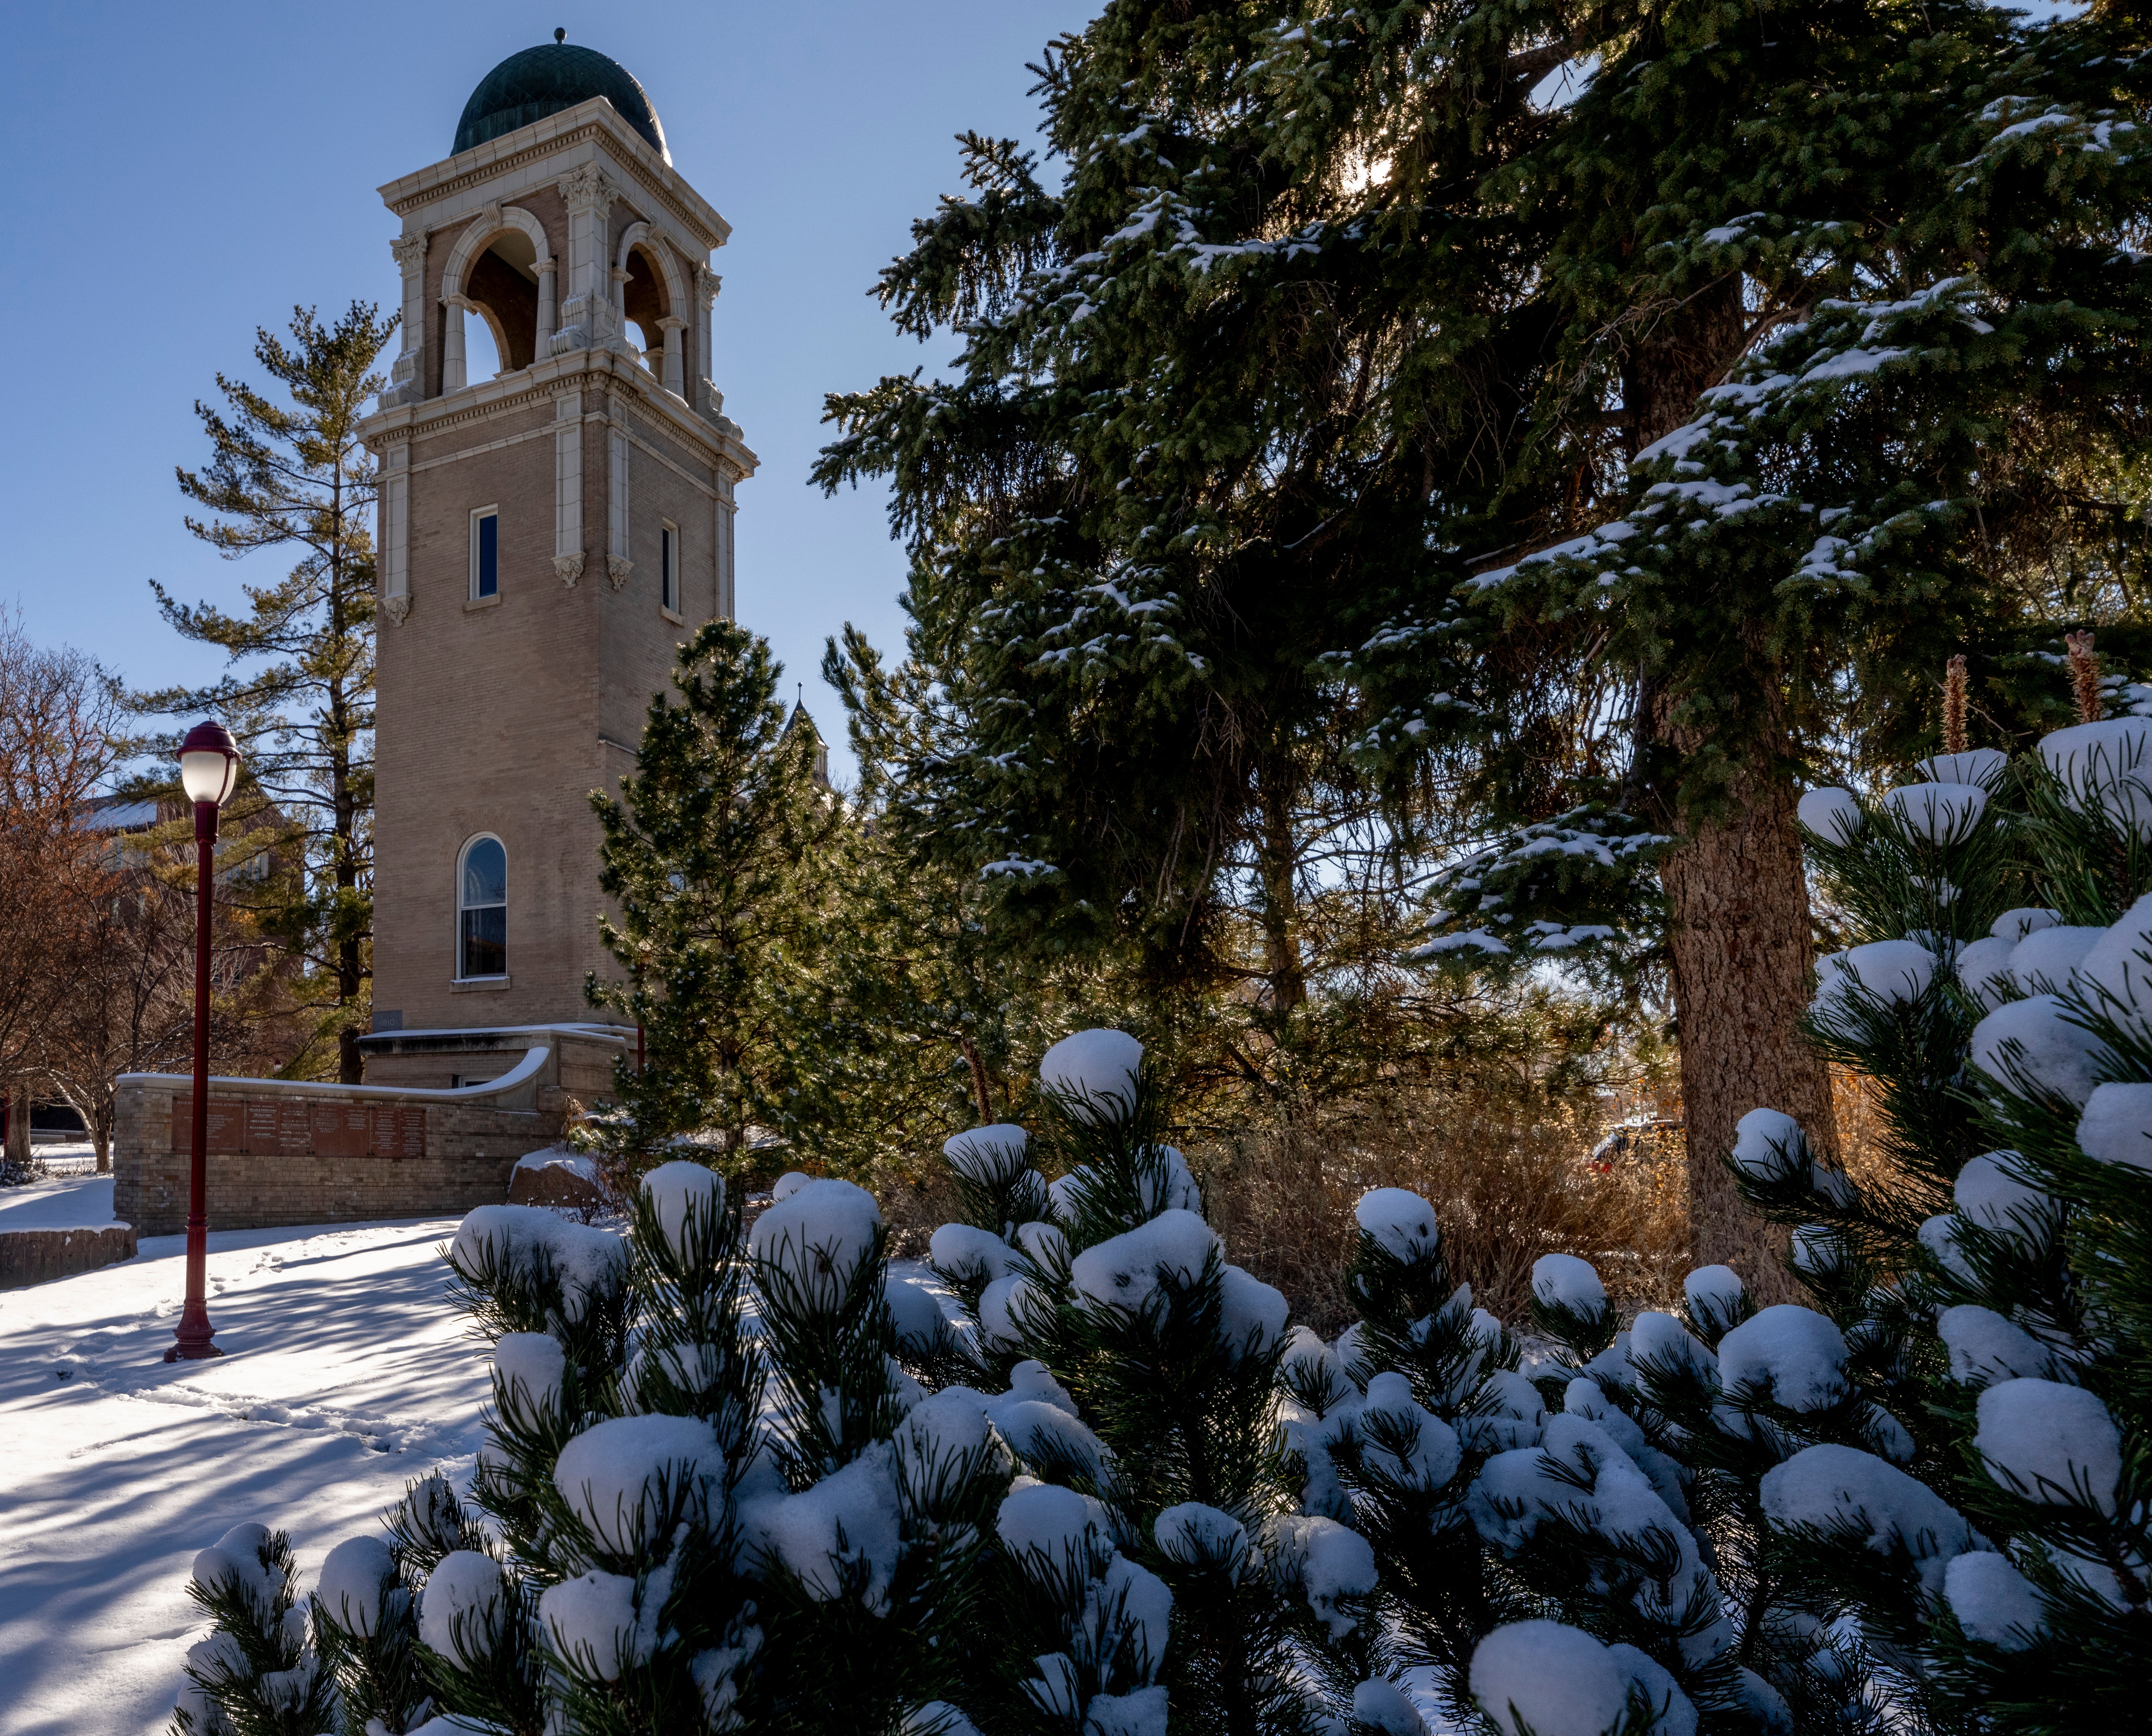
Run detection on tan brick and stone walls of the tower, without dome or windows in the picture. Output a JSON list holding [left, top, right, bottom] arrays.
[[366, 103, 755, 1058]]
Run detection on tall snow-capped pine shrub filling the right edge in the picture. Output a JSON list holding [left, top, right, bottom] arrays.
[[1720, 719, 2152, 1736]]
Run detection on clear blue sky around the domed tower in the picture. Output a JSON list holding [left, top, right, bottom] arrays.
[[0, 0, 1091, 783]]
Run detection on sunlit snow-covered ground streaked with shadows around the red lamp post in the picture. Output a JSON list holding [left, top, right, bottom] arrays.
[[0, 1177, 489, 1736]]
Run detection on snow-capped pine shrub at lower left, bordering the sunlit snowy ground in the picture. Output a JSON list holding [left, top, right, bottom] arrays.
[[181, 1162, 1009, 1736]]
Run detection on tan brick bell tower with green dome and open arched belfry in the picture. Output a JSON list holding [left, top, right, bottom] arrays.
[[362, 32, 755, 1084]]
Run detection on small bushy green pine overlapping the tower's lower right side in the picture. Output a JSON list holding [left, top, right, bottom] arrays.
[[587, 622, 844, 1162]]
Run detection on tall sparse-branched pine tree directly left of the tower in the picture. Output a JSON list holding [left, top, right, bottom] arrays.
[[134, 301, 396, 1084]]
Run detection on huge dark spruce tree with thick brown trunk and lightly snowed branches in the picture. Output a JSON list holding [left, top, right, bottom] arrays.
[[820, 0, 2143, 1302]]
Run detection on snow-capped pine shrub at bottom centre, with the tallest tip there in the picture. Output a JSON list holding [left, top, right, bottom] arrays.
[[932, 1030, 1373, 1736]]
